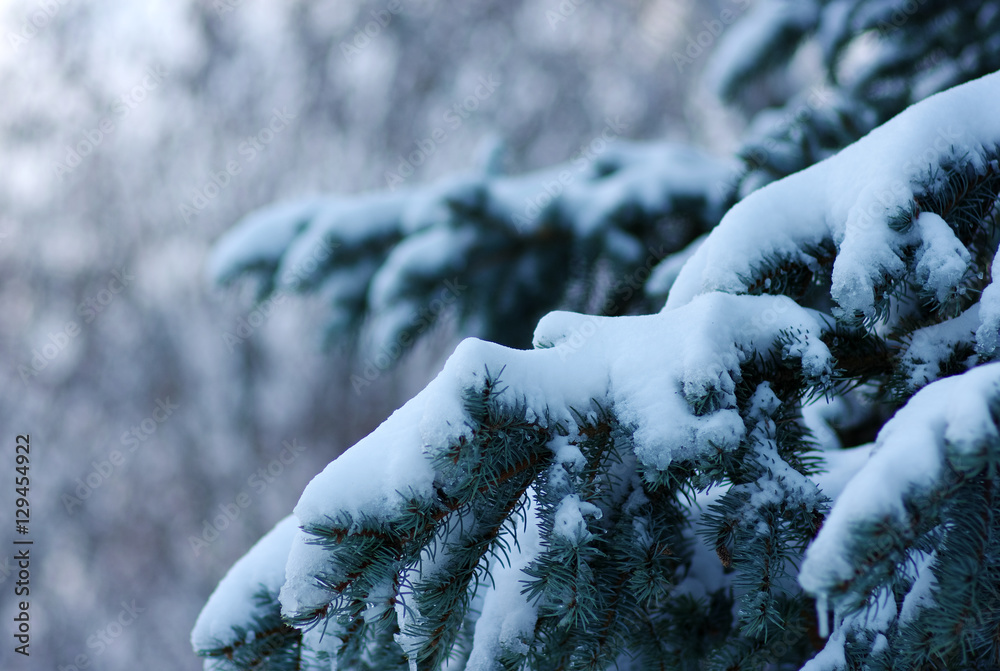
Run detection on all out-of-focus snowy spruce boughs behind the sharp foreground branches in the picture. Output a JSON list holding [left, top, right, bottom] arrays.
[[199, 0, 1000, 368]]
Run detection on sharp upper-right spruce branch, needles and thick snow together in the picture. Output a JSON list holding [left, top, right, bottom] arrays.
[[666, 75, 1000, 342]]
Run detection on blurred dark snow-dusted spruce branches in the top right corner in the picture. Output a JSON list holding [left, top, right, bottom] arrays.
[[705, 0, 1000, 195]]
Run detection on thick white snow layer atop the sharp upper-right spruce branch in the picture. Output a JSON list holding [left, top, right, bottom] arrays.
[[664, 74, 1000, 322]]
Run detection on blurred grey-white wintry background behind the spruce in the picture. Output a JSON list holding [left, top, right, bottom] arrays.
[[0, 0, 745, 670]]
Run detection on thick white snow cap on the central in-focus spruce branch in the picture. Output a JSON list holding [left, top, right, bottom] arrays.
[[281, 294, 830, 624]]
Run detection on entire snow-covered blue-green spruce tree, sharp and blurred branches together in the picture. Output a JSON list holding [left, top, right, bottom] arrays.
[[192, 0, 1000, 671]]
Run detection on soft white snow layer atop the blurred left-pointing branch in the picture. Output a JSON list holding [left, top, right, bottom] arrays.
[[208, 138, 737, 304]]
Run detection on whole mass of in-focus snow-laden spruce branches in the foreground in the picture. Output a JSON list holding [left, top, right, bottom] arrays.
[[193, 75, 1000, 669]]
